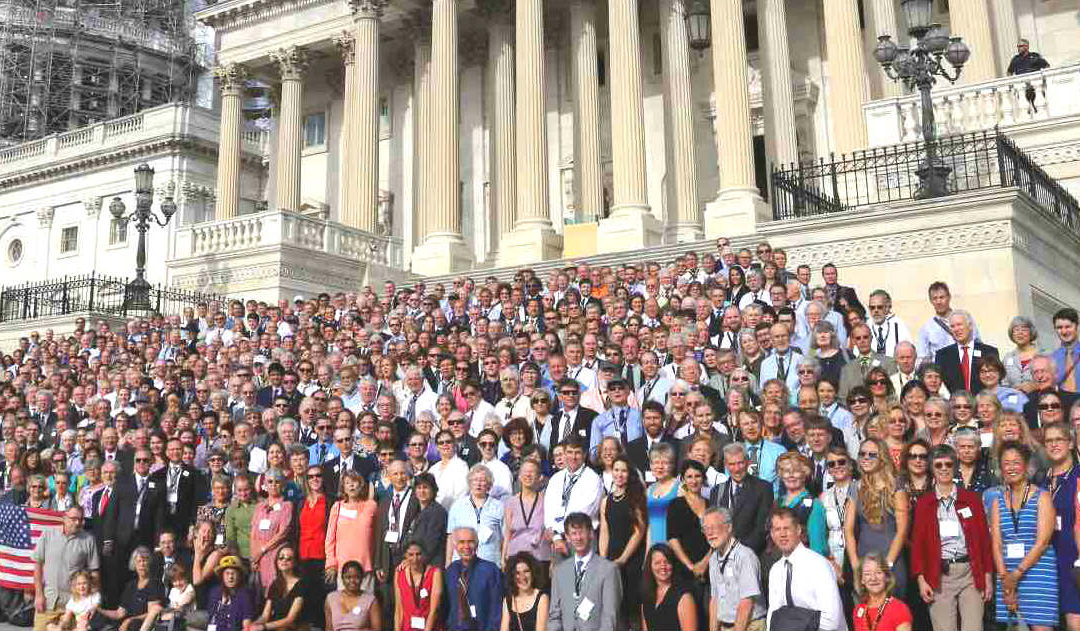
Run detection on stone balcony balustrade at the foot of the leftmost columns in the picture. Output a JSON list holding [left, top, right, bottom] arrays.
[[175, 211, 402, 267]]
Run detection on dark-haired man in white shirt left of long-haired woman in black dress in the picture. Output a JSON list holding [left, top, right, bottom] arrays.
[[543, 437, 604, 558]]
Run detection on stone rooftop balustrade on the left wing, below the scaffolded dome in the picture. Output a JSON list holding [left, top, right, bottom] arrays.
[[0, 103, 269, 174]]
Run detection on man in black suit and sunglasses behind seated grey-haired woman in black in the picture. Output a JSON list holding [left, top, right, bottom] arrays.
[[102, 448, 165, 602]]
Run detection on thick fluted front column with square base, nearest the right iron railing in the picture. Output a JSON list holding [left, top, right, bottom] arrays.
[[705, 0, 770, 239]]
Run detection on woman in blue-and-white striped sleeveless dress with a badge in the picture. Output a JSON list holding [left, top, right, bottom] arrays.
[[990, 441, 1058, 631]]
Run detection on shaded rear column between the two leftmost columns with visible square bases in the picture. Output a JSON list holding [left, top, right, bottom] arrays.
[[480, 0, 517, 254]]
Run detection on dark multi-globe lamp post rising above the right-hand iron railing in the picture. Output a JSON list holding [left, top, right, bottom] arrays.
[[874, 0, 971, 199]]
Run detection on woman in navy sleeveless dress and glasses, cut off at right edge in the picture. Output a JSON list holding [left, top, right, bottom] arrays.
[[1042, 422, 1080, 631]]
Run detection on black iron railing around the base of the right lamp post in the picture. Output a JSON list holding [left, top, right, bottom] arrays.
[[770, 131, 1080, 236]]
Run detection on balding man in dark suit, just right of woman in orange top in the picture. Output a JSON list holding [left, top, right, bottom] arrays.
[[375, 460, 420, 622]]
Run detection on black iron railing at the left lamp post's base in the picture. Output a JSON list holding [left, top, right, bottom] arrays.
[[0, 273, 225, 322]]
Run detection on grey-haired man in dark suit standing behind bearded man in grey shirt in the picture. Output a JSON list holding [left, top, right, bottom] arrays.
[[708, 443, 773, 554]]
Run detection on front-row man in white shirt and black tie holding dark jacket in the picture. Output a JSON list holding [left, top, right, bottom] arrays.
[[766, 508, 848, 631]]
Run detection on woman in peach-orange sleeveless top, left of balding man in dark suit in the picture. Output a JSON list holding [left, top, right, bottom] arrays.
[[326, 470, 378, 587]]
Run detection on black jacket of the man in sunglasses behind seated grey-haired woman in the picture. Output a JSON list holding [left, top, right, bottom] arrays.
[[103, 473, 165, 559]]
